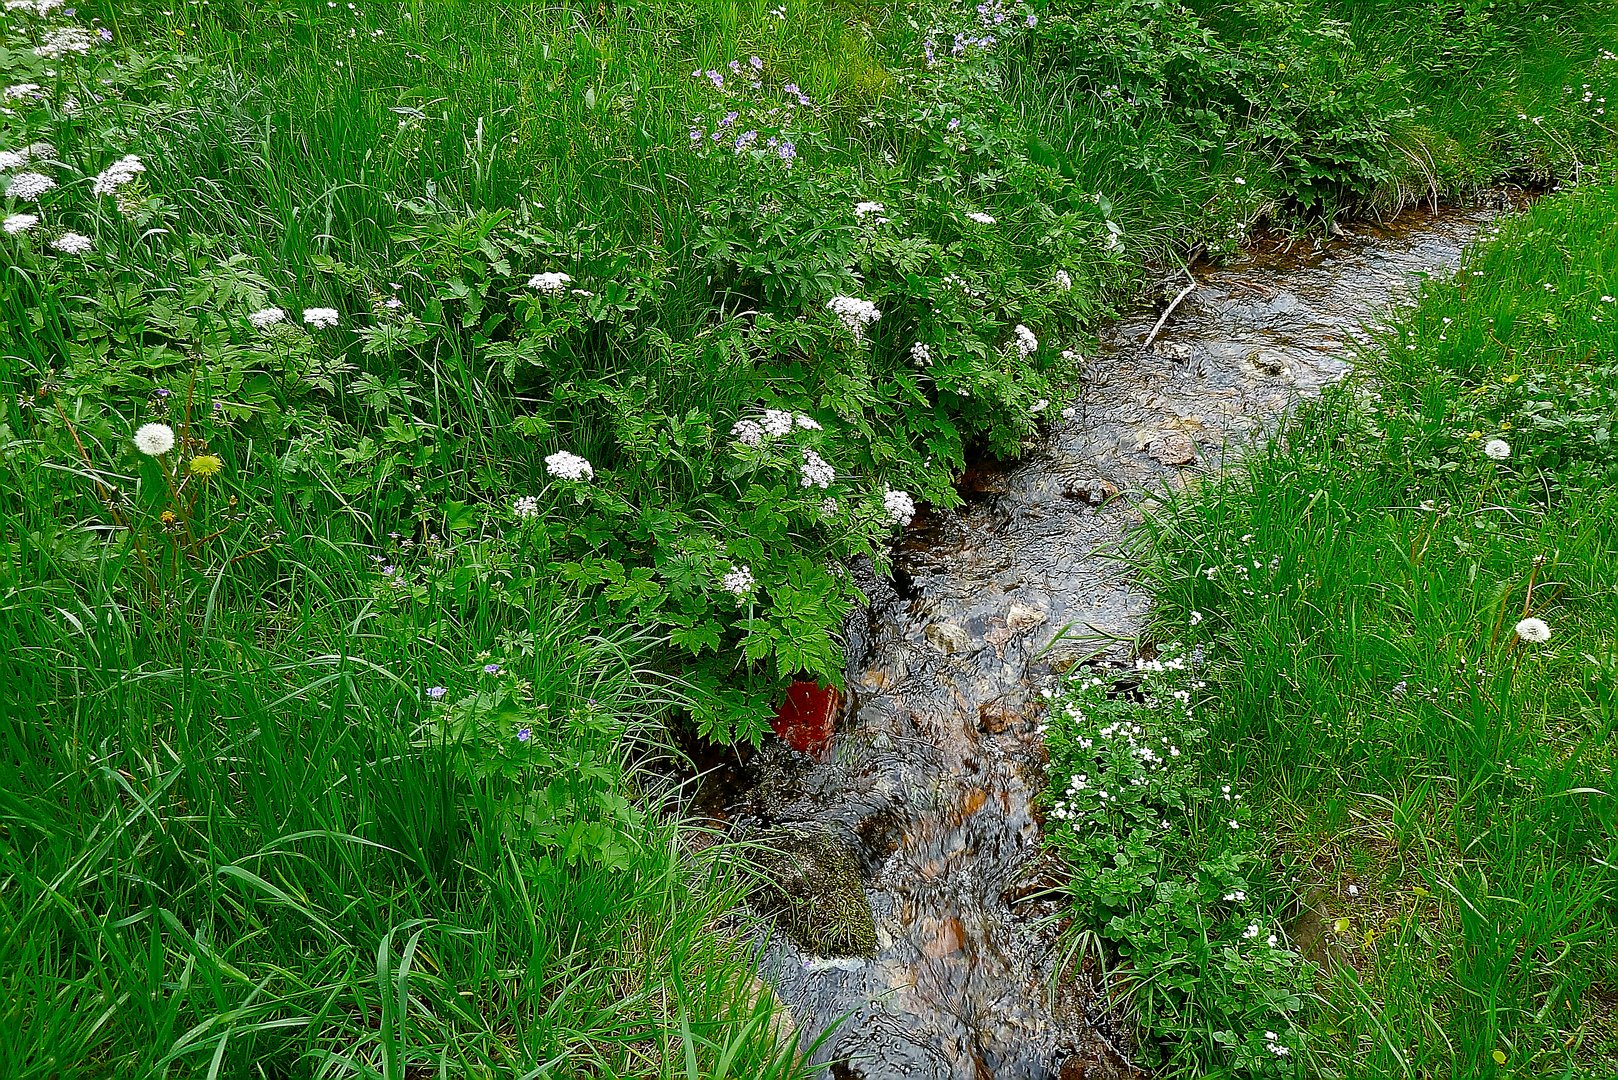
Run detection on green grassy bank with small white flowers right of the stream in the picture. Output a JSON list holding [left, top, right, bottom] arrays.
[[1052, 186, 1618, 1077]]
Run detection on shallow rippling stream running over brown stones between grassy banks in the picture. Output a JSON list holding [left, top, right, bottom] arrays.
[[726, 212, 1489, 1080]]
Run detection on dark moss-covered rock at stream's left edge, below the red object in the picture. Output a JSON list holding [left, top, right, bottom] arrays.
[[751, 826, 877, 957]]
